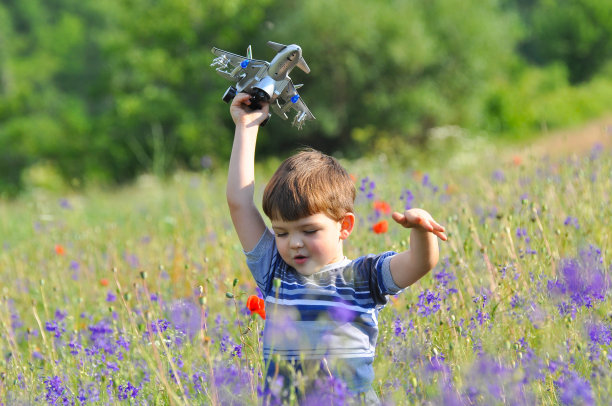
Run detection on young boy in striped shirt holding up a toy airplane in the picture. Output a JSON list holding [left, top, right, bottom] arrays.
[[226, 93, 446, 404]]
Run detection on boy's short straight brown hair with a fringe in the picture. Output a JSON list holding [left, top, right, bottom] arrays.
[[263, 149, 355, 221]]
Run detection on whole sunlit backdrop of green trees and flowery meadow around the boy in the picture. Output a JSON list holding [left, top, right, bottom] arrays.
[[0, 0, 612, 406]]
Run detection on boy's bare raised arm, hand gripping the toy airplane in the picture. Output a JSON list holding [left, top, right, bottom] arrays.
[[225, 93, 269, 252]]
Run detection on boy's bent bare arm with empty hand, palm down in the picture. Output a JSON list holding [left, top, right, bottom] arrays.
[[390, 209, 447, 288]]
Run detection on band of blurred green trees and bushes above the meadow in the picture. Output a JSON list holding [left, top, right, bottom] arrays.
[[0, 0, 612, 195]]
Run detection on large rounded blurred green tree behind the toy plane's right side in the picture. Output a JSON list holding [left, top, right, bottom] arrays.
[[260, 0, 517, 153]]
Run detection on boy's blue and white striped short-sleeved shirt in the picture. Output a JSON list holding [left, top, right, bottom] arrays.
[[246, 230, 401, 392]]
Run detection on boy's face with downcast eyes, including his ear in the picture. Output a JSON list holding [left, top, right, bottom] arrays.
[[272, 213, 355, 276]]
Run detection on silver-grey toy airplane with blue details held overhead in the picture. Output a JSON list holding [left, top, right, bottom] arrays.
[[210, 41, 315, 129]]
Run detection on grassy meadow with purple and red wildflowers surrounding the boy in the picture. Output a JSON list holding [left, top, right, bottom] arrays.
[[0, 133, 612, 405]]
